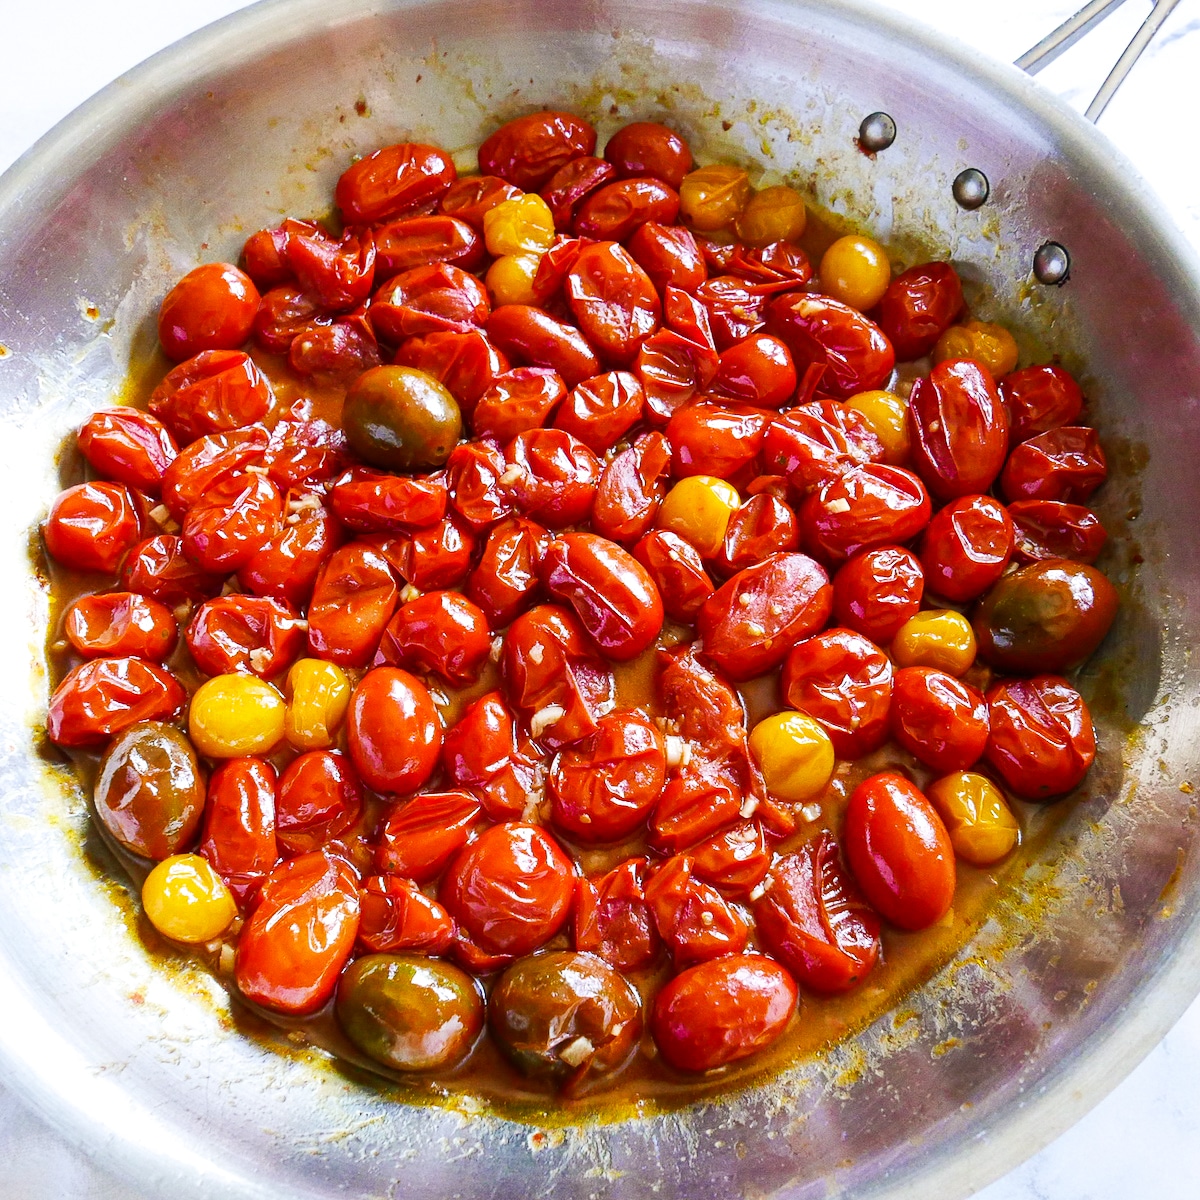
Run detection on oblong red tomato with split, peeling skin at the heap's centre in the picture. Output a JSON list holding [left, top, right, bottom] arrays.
[[540, 533, 662, 662]]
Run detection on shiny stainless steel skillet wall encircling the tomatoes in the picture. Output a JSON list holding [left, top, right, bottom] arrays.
[[0, 2, 1200, 1196]]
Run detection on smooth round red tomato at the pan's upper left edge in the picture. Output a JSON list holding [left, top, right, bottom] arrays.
[[158, 263, 259, 362]]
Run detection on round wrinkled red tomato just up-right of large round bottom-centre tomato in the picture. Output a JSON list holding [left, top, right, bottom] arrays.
[[550, 712, 667, 842]]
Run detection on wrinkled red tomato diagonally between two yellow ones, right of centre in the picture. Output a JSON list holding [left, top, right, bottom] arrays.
[[781, 629, 893, 758]]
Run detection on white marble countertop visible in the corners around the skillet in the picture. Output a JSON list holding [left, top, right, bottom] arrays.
[[0, 0, 1200, 1200]]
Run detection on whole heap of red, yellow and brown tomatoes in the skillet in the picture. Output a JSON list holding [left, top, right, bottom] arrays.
[[43, 113, 1116, 1090]]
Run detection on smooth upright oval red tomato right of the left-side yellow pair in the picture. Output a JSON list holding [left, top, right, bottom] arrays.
[[346, 667, 442, 796]]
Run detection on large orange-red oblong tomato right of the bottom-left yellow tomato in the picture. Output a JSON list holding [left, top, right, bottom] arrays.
[[234, 851, 359, 1016]]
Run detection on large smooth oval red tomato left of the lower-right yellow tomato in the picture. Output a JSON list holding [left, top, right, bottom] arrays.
[[842, 770, 956, 930]]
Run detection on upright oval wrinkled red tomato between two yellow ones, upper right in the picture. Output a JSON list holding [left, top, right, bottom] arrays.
[[908, 359, 1008, 500]]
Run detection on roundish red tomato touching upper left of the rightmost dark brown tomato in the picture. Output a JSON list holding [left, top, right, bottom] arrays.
[[920, 496, 1013, 604]]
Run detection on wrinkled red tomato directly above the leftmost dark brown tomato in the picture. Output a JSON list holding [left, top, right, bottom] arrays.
[[46, 658, 187, 746]]
